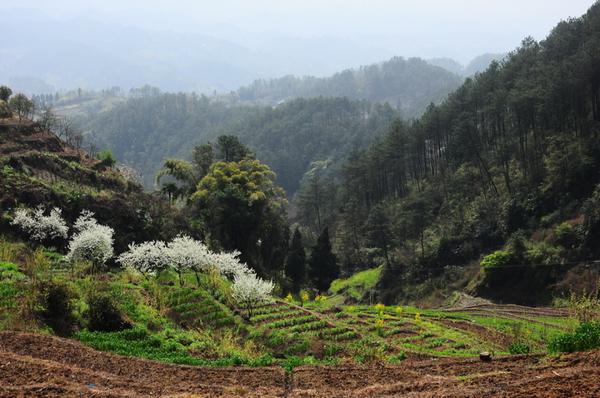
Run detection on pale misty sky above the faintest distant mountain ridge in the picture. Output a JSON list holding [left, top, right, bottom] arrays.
[[0, 0, 592, 63]]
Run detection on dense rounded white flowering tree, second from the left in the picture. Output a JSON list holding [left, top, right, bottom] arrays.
[[67, 210, 114, 272]]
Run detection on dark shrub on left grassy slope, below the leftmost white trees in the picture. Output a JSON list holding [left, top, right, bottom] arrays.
[[39, 282, 77, 336]]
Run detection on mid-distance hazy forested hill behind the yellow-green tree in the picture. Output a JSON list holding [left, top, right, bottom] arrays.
[[82, 94, 399, 195]]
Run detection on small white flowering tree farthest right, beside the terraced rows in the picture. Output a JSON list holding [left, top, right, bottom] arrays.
[[231, 273, 274, 319]]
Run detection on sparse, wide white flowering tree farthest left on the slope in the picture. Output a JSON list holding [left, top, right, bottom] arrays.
[[11, 206, 69, 243]]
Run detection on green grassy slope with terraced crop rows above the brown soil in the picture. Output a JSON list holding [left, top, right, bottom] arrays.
[[0, 233, 577, 367]]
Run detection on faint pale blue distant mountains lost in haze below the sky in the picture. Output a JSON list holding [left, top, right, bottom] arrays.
[[0, 8, 510, 95]]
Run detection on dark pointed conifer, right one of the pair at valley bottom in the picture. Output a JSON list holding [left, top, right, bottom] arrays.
[[308, 227, 340, 292]]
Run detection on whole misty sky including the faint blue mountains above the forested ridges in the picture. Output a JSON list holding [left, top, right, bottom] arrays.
[[0, 0, 593, 93]]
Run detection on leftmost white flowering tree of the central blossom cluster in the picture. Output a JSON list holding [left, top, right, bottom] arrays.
[[117, 241, 169, 277]]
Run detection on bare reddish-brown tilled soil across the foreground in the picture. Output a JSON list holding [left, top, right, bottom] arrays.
[[0, 332, 600, 398]]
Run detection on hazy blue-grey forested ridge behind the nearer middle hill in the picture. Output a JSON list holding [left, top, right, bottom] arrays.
[[238, 57, 462, 118]]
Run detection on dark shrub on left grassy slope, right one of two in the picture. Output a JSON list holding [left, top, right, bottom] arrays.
[[85, 294, 131, 332]]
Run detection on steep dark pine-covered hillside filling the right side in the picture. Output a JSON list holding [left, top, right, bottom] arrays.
[[308, 4, 600, 303]]
